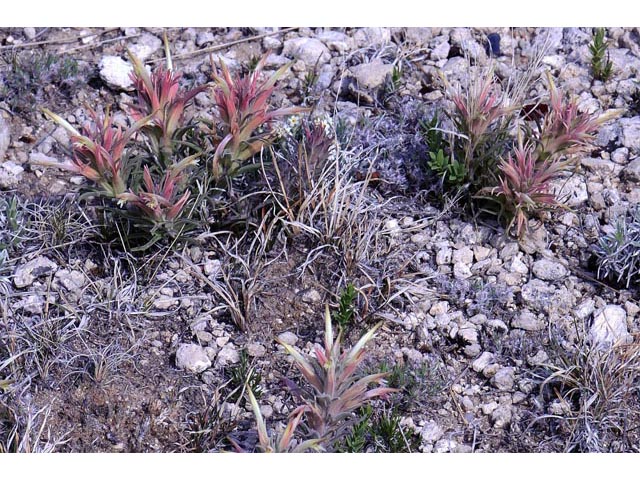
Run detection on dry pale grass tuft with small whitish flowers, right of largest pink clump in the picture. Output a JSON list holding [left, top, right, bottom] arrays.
[[263, 116, 384, 278]]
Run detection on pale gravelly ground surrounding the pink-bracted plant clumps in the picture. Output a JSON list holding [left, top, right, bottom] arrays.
[[0, 28, 640, 452]]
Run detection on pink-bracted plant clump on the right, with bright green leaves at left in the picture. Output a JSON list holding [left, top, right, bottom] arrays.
[[436, 64, 618, 237]]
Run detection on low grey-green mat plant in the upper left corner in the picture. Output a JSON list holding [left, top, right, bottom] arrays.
[[0, 52, 86, 114]]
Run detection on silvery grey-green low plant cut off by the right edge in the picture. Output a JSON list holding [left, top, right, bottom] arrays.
[[596, 205, 640, 288]]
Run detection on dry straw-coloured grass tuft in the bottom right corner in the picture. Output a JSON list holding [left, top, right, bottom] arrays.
[[536, 340, 640, 452]]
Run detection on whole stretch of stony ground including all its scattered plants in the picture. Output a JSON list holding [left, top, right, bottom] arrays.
[[0, 28, 640, 452]]
